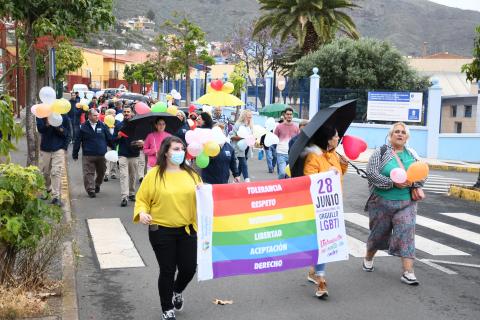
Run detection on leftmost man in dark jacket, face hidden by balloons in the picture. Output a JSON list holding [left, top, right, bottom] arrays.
[[37, 115, 70, 206]]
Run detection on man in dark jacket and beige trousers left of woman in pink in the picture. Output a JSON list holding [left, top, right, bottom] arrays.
[[113, 106, 143, 207]]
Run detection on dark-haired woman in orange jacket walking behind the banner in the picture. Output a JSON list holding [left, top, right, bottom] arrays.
[[303, 126, 348, 298]]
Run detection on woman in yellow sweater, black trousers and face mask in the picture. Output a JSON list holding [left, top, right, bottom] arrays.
[[133, 136, 201, 320]]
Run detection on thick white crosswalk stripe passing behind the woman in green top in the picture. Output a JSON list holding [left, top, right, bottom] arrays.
[[345, 212, 470, 256]]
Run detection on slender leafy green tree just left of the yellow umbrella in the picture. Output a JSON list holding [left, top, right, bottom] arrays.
[[162, 13, 215, 106]]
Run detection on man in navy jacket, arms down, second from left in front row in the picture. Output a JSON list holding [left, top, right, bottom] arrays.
[[72, 109, 112, 198]]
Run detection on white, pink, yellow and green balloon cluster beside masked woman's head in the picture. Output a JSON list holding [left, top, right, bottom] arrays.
[[185, 127, 226, 169]]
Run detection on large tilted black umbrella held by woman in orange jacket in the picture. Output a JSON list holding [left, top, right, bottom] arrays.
[[288, 100, 357, 177]]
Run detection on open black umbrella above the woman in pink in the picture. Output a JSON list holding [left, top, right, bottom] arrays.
[[120, 112, 182, 140]]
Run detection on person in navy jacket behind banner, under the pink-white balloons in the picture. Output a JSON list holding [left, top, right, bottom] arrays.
[[202, 142, 240, 184]]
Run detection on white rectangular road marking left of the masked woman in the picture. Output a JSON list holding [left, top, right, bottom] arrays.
[[87, 218, 145, 269]]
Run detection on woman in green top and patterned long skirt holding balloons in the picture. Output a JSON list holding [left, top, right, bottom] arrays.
[[362, 122, 423, 285]]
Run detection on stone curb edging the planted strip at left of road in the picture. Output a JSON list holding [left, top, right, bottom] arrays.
[[61, 156, 78, 320]]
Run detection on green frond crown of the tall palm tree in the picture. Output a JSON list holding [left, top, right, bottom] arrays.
[[254, 0, 359, 54]]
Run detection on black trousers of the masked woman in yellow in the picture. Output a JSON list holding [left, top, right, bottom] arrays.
[[148, 225, 197, 311]]
